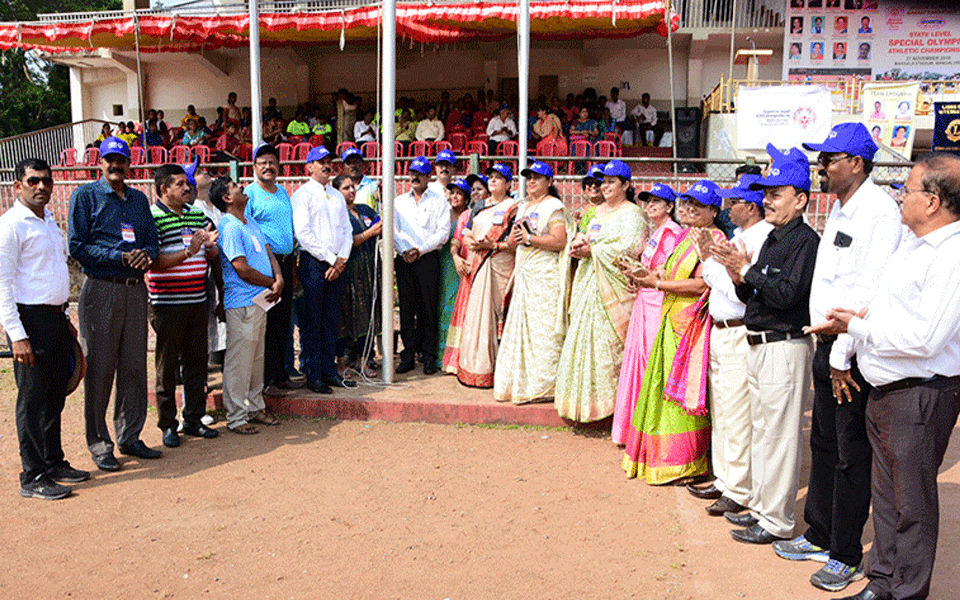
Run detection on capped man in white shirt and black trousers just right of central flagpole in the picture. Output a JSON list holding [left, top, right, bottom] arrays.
[[394, 156, 450, 375]]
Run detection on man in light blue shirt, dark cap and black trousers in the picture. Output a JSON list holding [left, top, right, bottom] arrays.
[[244, 143, 303, 398]]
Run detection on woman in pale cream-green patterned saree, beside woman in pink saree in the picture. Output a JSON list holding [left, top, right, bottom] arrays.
[[555, 160, 649, 423]]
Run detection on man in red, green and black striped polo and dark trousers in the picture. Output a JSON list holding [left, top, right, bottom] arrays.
[[148, 165, 218, 448]]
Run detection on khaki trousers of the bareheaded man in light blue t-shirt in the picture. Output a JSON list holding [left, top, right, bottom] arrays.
[[223, 305, 267, 428]]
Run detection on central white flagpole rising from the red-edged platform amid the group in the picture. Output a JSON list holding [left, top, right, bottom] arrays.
[[380, 0, 397, 383]]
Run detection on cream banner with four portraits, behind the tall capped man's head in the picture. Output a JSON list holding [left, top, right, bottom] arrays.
[[862, 83, 920, 159]]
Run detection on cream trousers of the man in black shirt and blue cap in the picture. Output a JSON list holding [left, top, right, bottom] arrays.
[[747, 336, 813, 538]]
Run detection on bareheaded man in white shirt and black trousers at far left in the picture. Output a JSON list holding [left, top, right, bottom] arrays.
[[0, 158, 90, 500]]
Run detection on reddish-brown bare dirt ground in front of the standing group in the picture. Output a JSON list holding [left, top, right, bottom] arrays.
[[0, 360, 960, 600]]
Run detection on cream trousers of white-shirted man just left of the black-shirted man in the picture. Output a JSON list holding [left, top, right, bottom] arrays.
[[710, 325, 753, 506]]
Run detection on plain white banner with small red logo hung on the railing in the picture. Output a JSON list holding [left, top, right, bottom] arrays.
[[737, 85, 833, 150]]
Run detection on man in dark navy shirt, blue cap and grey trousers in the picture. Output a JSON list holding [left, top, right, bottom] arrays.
[[69, 137, 161, 471]]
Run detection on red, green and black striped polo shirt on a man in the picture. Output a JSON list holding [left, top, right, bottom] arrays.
[[147, 201, 213, 305]]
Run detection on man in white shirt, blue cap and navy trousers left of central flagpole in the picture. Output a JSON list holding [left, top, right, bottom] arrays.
[[290, 146, 357, 394]]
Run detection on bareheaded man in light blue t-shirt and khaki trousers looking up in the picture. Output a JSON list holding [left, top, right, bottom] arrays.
[[210, 177, 284, 434]]
